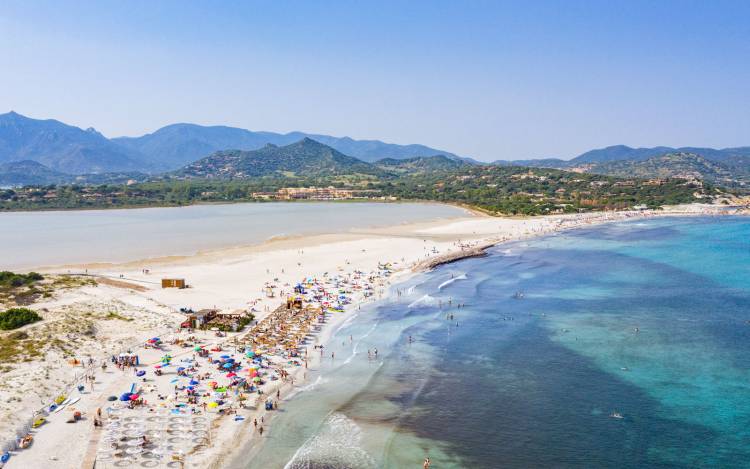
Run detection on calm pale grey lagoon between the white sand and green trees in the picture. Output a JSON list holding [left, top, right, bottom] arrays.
[[0, 202, 468, 270]]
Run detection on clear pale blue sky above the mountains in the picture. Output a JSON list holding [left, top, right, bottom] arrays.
[[0, 0, 750, 160]]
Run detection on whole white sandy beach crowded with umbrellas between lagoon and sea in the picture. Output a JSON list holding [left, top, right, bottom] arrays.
[[0, 206, 740, 468]]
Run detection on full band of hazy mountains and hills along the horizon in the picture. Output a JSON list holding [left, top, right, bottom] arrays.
[[0, 112, 750, 186]]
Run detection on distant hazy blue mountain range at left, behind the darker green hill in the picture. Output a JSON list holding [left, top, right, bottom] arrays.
[[0, 111, 459, 174]]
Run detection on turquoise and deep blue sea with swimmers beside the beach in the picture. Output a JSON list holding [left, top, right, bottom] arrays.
[[235, 217, 750, 468]]
